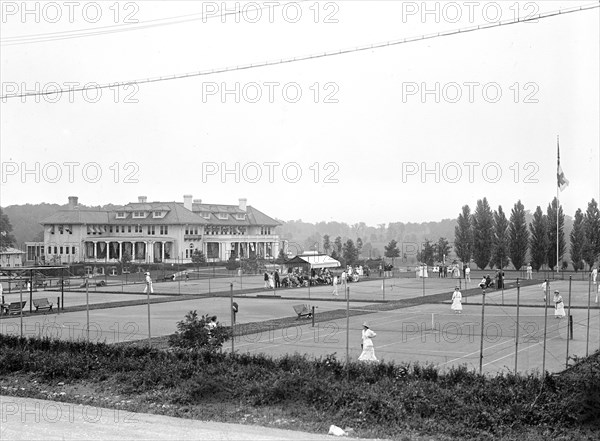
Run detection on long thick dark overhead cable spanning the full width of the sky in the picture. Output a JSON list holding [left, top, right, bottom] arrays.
[[0, 3, 600, 100]]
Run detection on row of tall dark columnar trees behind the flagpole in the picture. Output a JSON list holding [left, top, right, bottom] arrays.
[[454, 198, 600, 271]]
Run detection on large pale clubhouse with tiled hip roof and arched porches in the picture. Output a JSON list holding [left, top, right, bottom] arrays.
[[27, 195, 280, 264]]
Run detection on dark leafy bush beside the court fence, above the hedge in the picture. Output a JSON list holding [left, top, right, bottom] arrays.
[[169, 311, 231, 351]]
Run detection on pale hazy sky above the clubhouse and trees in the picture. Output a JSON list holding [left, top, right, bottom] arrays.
[[0, 1, 600, 225]]
